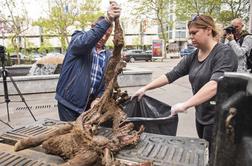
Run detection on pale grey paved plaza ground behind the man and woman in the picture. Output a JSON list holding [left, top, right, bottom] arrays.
[[0, 58, 197, 137]]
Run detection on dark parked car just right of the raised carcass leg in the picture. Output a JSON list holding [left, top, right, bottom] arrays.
[[122, 49, 152, 62]]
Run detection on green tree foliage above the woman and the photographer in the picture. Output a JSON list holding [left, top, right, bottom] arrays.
[[174, 0, 249, 25]]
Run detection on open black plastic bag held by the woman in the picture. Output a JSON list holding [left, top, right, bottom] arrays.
[[122, 95, 178, 136]]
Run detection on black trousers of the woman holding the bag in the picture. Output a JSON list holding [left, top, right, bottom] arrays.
[[196, 120, 214, 155]]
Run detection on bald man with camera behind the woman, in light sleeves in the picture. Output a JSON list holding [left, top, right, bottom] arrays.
[[226, 18, 252, 72]]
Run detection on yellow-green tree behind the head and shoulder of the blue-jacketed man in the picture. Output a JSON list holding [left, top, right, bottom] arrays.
[[33, 0, 101, 52]]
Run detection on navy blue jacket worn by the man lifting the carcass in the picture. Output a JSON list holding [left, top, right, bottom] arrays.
[[55, 20, 111, 113]]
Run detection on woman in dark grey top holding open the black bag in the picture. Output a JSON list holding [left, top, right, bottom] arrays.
[[132, 15, 237, 150]]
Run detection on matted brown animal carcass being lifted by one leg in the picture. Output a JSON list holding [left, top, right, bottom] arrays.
[[12, 18, 149, 166]]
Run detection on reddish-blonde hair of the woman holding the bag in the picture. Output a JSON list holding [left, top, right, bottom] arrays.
[[187, 15, 218, 37]]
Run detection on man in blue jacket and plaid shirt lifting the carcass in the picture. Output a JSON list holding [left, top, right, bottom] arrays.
[[55, 1, 121, 121]]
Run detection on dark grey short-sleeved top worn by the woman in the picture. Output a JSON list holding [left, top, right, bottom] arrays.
[[166, 43, 238, 125]]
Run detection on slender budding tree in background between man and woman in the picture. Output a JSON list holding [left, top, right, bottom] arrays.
[[129, 0, 170, 58]]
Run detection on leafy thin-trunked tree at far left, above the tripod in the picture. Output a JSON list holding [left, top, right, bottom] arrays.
[[1, 0, 29, 64]]
